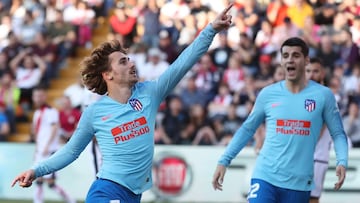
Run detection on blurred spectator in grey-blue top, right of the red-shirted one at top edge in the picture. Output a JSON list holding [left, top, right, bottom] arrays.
[[142, 0, 161, 47]]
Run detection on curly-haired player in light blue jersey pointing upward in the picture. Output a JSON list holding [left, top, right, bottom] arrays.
[[12, 4, 232, 203]]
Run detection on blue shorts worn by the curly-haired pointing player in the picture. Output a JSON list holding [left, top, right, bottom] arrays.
[[85, 178, 141, 203]]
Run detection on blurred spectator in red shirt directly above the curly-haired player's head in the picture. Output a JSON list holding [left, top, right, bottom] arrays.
[[109, 2, 138, 47]]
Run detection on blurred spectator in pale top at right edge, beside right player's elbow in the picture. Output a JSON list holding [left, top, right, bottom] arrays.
[[343, 102, 360, 148]]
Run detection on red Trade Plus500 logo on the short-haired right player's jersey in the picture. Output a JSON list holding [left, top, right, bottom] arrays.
[[276, 119, 311, 136]]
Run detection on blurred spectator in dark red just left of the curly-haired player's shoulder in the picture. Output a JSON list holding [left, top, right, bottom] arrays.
[[59, 96, 81, 143]]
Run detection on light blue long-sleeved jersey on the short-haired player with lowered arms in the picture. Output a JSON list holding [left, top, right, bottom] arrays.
[[219, 81, 348, 191]]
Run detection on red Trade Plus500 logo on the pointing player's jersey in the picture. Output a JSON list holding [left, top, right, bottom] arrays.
[[111, 117, 150, 144]]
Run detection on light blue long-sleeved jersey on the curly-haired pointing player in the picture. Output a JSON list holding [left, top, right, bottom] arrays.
[[33, 25, 216, 194]]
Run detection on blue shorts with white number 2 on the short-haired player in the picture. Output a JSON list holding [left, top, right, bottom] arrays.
[[247, 179, 310, 203]]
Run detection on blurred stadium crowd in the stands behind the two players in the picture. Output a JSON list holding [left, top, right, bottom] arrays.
[[0, 0, 360, 148]]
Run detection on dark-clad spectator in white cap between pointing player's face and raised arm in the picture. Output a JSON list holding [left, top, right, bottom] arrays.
[[159, 29, 179, 64]]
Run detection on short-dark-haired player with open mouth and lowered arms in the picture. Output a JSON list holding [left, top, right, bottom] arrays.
[[212, 37, 348, 203]]
